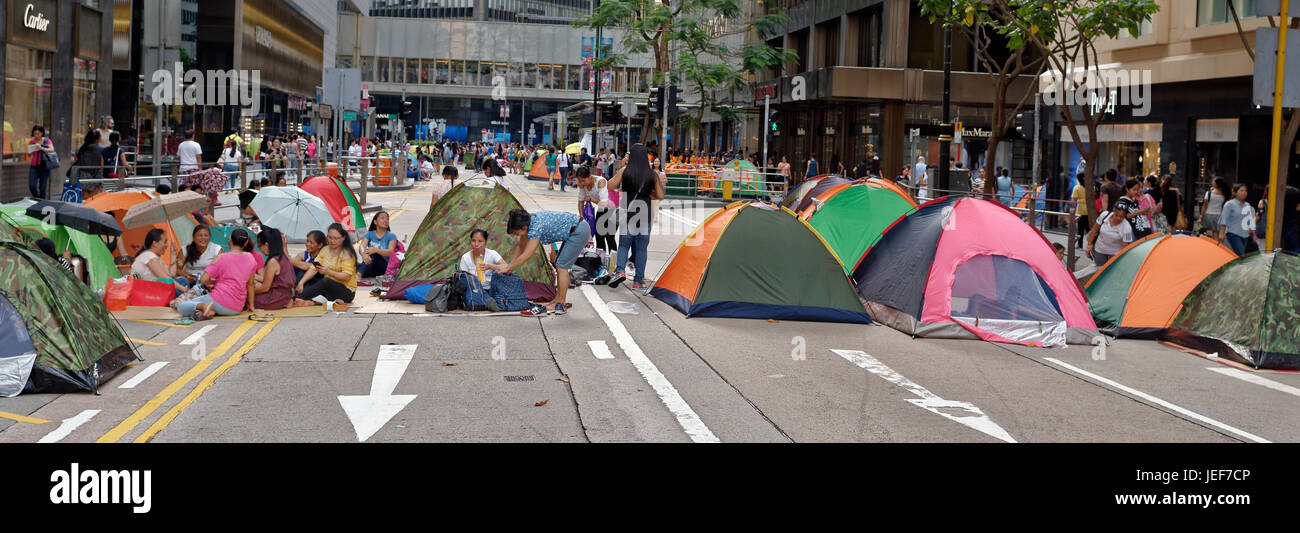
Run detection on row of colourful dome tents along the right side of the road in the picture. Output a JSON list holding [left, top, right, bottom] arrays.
[[650, 177, 1300, 368]]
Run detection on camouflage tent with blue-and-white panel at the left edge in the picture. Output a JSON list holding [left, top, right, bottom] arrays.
[[0, 242, 137, 397]]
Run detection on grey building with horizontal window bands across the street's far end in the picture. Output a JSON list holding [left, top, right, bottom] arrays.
[[335, 0, 654, 144]]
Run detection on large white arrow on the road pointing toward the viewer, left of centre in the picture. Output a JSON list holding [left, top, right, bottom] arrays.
[[338, 345, 419, 442]]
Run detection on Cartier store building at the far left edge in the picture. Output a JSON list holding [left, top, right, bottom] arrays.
[[0, 0, 114, 200]]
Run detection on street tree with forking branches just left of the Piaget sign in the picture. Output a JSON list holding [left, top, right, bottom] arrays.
[[1006, 0, 1160, 220]]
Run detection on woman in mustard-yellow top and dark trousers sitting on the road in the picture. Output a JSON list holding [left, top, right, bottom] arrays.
[[294, 222, 356, 311]]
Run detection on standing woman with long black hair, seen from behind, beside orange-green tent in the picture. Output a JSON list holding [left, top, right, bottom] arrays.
[[607, 143, 663, 290]]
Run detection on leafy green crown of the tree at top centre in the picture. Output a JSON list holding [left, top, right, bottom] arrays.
[[573, 0, 798, 142]]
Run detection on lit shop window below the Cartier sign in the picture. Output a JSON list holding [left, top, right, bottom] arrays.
[[4, 44, 55, 161]]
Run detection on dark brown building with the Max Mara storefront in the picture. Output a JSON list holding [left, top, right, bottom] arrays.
[[745, 0, 1035, 182]]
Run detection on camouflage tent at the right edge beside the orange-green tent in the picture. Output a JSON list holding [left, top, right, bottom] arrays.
[[1169, 252, 1300, 371]]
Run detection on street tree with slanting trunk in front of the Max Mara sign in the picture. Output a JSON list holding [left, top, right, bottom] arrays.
[[920, 0, 1044, 198]]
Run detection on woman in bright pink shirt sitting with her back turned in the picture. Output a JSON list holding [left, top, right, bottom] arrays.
[[176, 229, 263, 320]]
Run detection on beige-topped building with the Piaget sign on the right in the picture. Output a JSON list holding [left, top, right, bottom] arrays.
[[1044, 0, 1300, 218]]
